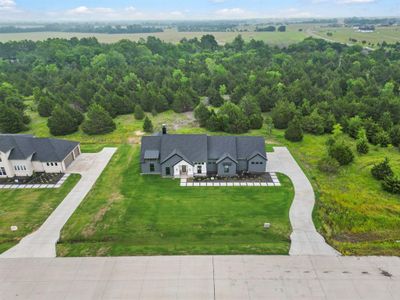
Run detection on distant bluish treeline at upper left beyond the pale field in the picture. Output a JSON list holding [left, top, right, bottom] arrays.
[[0, 24, 164, 34]]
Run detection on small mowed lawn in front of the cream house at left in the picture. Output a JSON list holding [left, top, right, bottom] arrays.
[[0, 175, 80, 253]]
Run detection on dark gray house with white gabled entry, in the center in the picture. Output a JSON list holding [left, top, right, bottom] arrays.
[[140, 129, 267, 177]]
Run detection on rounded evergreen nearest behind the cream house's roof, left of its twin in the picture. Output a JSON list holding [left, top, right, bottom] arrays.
[[47, 106, 78, 135]]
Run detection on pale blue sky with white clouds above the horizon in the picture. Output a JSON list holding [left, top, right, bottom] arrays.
[[0, 0, 400, 21]]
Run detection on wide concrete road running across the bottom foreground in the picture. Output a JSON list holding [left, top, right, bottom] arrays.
[[0, 256, 400, 300]]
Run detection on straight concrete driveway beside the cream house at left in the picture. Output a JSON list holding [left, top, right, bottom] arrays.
[[0, 148, 116, 258]]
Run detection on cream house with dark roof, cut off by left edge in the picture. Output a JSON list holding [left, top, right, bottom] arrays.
[[0, 134, 81, 178]]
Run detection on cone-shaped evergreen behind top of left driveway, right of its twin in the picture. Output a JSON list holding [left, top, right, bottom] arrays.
[[82, 103, 116, 135]]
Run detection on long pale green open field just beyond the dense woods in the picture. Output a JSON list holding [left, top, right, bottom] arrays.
[[0, 26, 306, 46]]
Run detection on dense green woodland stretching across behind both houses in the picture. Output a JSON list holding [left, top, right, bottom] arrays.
[[0, 35, 400, 146]]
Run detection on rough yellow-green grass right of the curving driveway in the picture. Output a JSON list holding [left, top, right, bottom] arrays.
[[273, 130, 400, 255]]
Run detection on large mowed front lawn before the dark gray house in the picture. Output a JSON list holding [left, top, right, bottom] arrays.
[[57, 145, 294, 256]]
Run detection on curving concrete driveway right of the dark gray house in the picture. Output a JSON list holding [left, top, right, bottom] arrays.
[[267, 147, 340, 255]]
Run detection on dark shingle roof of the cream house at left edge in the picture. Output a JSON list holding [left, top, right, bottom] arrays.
[[0, 134, 79, 162]]
